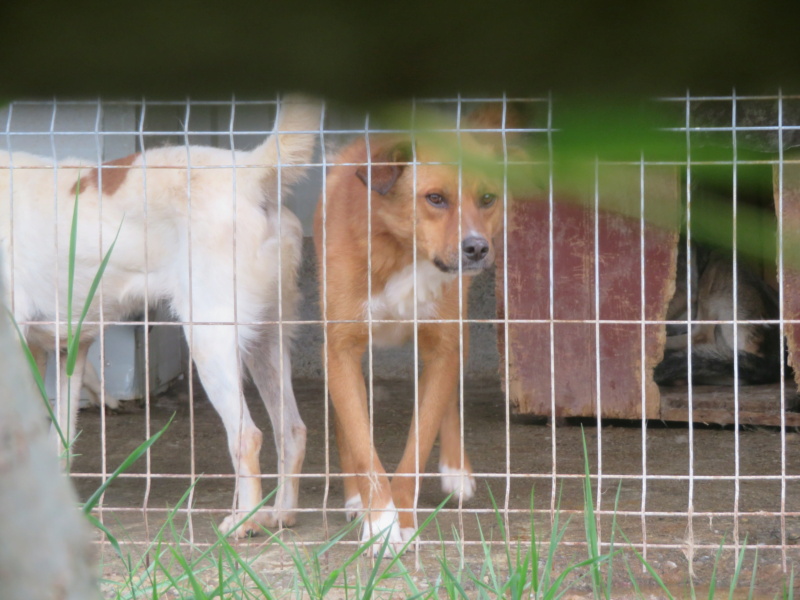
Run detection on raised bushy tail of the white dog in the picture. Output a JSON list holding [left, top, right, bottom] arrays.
[[249, 95, 322, 185]]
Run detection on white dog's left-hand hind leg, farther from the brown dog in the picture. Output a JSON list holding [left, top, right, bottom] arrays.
[[184, 325, 262, 537]]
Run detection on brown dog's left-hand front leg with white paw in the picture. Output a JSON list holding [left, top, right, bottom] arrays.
[[328, 332, 404, 553]]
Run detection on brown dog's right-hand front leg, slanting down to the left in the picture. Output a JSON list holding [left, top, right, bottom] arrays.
[[392, 324, 466, 536]]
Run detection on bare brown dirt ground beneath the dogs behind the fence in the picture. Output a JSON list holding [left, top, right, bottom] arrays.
[[72, 381, 800, 595]]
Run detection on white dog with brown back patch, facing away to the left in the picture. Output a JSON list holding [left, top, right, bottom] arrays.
[[0, 98, 320, 537]]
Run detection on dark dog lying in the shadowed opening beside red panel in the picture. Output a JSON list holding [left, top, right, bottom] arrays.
[[653, 240, 784, 385]]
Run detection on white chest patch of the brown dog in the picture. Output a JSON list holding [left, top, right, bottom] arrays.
[[364, 260, 457, 346]]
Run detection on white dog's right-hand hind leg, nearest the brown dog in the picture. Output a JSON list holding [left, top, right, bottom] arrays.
[[244, 327, 306, 527]]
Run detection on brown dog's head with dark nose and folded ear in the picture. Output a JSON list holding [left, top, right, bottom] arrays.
[[356, 105, 520, 274]]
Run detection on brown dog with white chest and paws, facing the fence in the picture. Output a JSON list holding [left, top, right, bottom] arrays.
[[314, 106, 503, 551]]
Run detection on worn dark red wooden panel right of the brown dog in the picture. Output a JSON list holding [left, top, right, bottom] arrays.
[[497, 166, 680, 418]]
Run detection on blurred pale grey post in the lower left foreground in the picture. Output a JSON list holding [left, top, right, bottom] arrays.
[[0, 289, 99, 600]]
